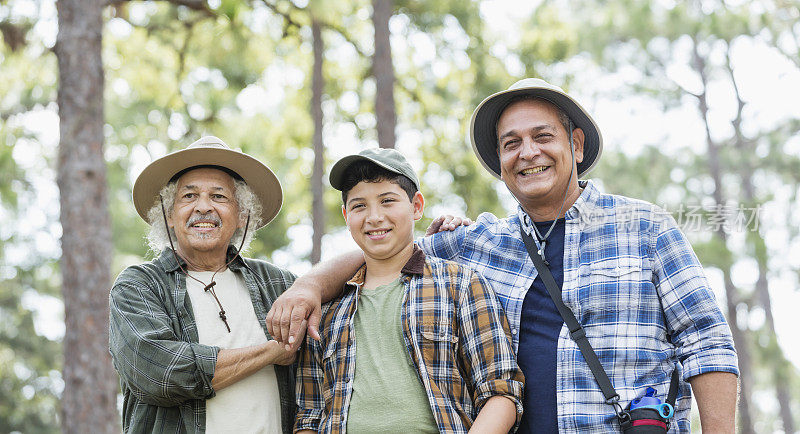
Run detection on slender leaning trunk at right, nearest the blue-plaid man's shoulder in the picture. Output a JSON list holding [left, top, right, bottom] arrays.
[[692, 40, 755, 434]]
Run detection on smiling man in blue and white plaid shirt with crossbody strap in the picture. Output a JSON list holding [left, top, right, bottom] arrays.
[[268, 79, 738, 433]]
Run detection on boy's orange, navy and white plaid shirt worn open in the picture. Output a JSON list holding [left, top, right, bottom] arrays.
[[295, 247, 524, 433]]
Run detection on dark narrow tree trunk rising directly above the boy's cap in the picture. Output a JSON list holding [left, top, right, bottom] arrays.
[[372, 0, 397, 148]]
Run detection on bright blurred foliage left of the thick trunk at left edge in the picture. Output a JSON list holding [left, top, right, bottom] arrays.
[[0, 2, 63, 433]]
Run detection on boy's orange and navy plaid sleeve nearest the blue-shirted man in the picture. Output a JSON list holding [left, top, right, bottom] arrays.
[[459, 271, 525, 429]]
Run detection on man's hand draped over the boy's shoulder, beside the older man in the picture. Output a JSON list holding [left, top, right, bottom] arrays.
[[267, 277, 322, 353]]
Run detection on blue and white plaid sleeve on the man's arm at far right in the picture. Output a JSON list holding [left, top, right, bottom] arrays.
[[653, 217, 739, 379]]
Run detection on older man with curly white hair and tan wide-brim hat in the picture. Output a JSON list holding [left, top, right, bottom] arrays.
[[109, 137, 296, 433]]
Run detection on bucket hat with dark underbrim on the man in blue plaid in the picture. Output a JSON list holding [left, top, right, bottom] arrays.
[[469, 78, 603, 179]]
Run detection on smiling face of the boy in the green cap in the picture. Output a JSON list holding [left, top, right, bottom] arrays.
[[342, 181, 423, 261]]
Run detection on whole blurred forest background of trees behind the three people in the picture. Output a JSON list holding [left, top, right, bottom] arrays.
[[0, 0, 800, 433]]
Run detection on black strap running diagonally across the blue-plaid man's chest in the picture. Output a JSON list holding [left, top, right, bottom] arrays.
[[520, 225, 619, 408]]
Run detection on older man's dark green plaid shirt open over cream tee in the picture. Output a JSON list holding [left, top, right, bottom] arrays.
[[109, 247, 296, 433]]
